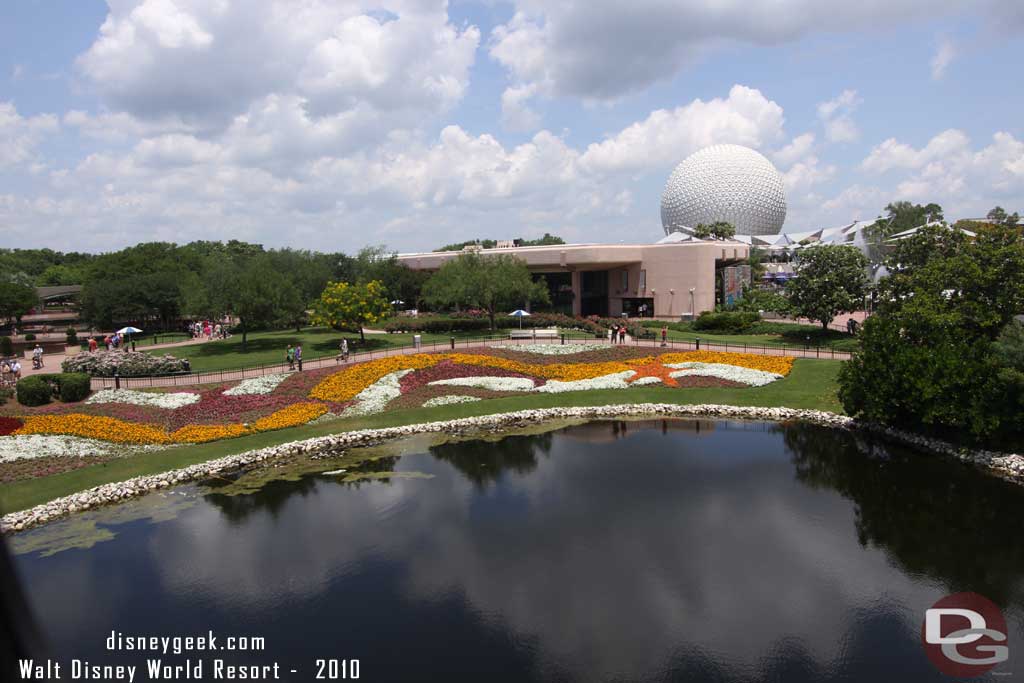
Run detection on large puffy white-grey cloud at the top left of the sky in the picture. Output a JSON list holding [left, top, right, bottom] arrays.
[[78, 0, 479, 139]]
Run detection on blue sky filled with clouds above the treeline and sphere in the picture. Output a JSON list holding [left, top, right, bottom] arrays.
[[0, 0, 1024, 252]]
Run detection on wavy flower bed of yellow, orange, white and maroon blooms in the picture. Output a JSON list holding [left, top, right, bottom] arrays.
[[0, 344, 793, 449]]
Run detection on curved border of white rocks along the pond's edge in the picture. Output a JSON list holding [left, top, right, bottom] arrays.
[[0, 403, 1024, 533]]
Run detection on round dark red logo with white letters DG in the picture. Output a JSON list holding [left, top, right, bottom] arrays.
[[921, 593, 1010, 678]]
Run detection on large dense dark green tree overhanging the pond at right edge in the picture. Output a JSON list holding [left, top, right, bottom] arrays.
[[840, 225, 1024, 439]]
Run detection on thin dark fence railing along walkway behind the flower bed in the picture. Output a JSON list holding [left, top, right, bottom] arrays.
[[92, 332, 850, 389]]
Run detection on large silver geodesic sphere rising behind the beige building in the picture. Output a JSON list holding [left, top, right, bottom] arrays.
[[662, 144, 785, 234]]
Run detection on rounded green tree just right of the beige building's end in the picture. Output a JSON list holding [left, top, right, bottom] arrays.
[[785, 245, 868, 329]]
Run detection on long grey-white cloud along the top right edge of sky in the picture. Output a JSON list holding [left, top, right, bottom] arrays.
[[489, 0, 1021, 99]]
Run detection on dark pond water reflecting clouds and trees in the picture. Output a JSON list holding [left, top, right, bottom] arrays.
[[8, 421, 1024, 682]]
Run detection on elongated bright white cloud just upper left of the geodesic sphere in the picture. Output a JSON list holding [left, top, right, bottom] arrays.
[[581, 85, 784, 172]]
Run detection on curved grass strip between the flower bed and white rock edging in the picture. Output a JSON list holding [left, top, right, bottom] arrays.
[[0, 359, 843, 512]]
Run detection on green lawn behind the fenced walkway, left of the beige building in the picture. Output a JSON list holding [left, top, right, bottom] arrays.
[[144, 328, 512, 372]]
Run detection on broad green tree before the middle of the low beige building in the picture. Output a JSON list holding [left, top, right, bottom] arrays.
[[423, 252, 551, 330]]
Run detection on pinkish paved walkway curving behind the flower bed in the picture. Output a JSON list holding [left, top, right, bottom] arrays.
[[90, 339, 850, 390]]
